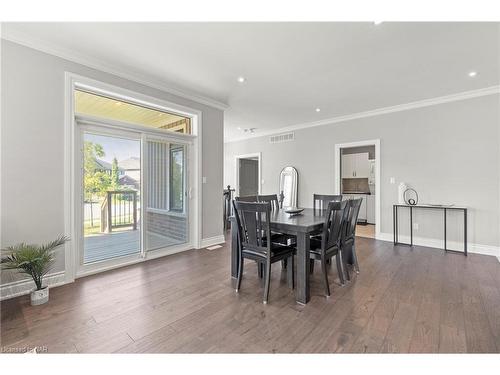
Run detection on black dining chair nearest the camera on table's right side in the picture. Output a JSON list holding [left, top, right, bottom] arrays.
[[309, 201, 348, 296]]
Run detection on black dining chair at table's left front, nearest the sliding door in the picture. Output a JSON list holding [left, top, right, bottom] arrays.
[[233, 201, 295, 304]]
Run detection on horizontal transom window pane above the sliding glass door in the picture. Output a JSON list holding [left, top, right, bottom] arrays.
[[75, 90, 191, 134]]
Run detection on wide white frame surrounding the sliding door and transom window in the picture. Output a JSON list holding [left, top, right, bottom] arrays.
[[64, 72, 203, 283]]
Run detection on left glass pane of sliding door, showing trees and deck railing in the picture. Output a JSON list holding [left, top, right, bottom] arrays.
[[83, 132, 141, 264]]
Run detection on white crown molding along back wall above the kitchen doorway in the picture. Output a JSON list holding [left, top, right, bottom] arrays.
[[224, 85, 500, 143]]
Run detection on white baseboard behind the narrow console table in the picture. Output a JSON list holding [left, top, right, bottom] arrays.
[[377, 233, 500, 260]]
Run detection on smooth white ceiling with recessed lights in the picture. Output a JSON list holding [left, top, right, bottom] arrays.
[[3, 22, 500, 140]]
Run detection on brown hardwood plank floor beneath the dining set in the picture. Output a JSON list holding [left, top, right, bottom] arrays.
[[1, 238, 500, 353]]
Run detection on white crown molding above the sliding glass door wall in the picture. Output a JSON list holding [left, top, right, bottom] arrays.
[[1, 27, 229, 110]]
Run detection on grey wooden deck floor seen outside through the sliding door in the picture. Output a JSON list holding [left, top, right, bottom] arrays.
[[84, 230, 186, 263]]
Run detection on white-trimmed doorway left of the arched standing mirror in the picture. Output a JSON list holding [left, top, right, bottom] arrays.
[[236, 153, 261, 197]]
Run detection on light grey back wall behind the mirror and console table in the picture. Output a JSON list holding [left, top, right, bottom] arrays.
[[224, 95, 500, 255]]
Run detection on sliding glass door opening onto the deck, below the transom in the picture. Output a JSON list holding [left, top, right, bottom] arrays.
[[79, 123, 190, 273]]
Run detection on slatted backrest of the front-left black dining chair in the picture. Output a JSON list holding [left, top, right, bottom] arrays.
[[233, 201, 271, 257]]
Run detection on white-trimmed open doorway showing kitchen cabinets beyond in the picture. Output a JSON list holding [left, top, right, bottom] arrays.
[[335, 140, 380, 238]]
